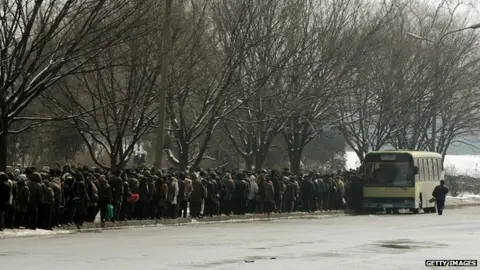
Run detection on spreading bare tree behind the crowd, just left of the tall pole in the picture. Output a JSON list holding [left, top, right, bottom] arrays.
[[52, 29, 160, 170]]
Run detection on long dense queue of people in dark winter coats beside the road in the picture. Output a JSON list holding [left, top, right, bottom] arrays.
[[0, 165, 362, 231]]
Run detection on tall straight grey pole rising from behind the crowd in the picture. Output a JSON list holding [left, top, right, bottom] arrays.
[[155, 0, 172, 169]]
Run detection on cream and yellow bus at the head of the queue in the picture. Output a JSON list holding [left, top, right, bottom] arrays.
[[362, 150, 445, 214]]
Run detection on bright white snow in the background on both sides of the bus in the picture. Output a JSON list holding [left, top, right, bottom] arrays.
[[346, 151, 480, 177]]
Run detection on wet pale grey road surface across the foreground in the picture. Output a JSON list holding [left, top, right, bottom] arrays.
[[0, 208, 480, 270]]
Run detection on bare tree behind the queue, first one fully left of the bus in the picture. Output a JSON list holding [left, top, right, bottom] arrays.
[[282, 0, 398, 173]]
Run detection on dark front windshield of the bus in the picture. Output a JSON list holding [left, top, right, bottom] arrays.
[[365, 162, 415, 187]]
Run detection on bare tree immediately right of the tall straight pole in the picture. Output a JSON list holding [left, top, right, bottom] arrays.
[[167, 0, 268, 169]]
